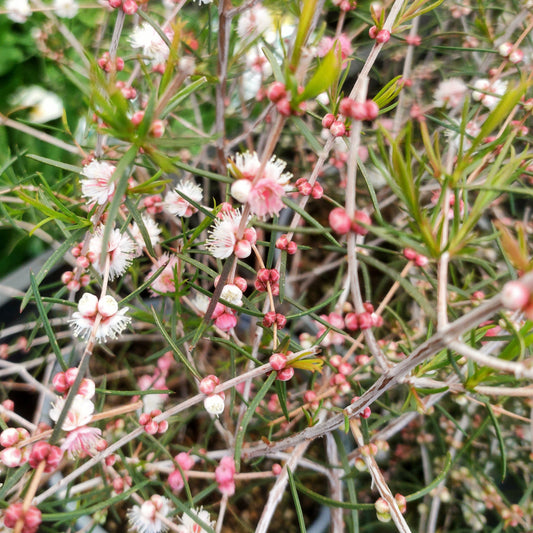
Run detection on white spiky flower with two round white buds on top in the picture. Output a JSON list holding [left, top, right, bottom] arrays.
[[69, 295, 131, 342]]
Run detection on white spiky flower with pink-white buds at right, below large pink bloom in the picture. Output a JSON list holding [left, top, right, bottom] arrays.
[[205, 209, 257, 259]]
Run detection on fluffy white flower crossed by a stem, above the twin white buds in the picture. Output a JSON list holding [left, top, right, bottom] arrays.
[[89, 226, 135, 280]]
